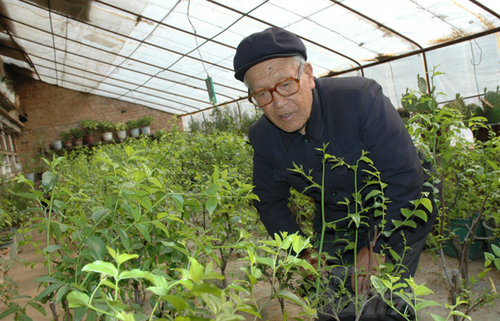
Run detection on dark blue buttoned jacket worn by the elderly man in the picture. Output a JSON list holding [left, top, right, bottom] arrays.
[[249, 77, 433, 251]]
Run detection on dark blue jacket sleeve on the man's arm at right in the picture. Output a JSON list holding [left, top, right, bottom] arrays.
[[358, 80, 428, 251]]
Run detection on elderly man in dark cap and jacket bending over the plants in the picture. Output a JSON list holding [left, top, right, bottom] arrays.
[[234, 28, 436, 320]]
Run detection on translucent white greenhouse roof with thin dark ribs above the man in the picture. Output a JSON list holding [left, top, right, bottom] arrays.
[[0, 0, 500, 115]]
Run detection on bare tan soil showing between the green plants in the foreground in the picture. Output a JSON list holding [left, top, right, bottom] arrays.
[[0, 231, 500, 321]]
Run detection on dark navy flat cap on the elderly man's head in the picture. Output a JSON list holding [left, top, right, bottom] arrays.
[[233, 28, 307, 81]]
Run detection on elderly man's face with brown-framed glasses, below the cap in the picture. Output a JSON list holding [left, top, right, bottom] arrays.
[[245, 58, 315, 134]]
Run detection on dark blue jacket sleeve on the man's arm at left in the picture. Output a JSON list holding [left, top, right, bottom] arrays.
[[249, 116, 305, 238]]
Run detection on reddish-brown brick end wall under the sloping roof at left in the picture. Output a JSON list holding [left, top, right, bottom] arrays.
[[12, 75, 182, 168]]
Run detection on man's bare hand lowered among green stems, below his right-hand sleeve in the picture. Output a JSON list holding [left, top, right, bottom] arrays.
[[351, 247, 385, 293]]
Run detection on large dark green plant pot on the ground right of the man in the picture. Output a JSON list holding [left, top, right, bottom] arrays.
[[443, 218, 486, 260]]
